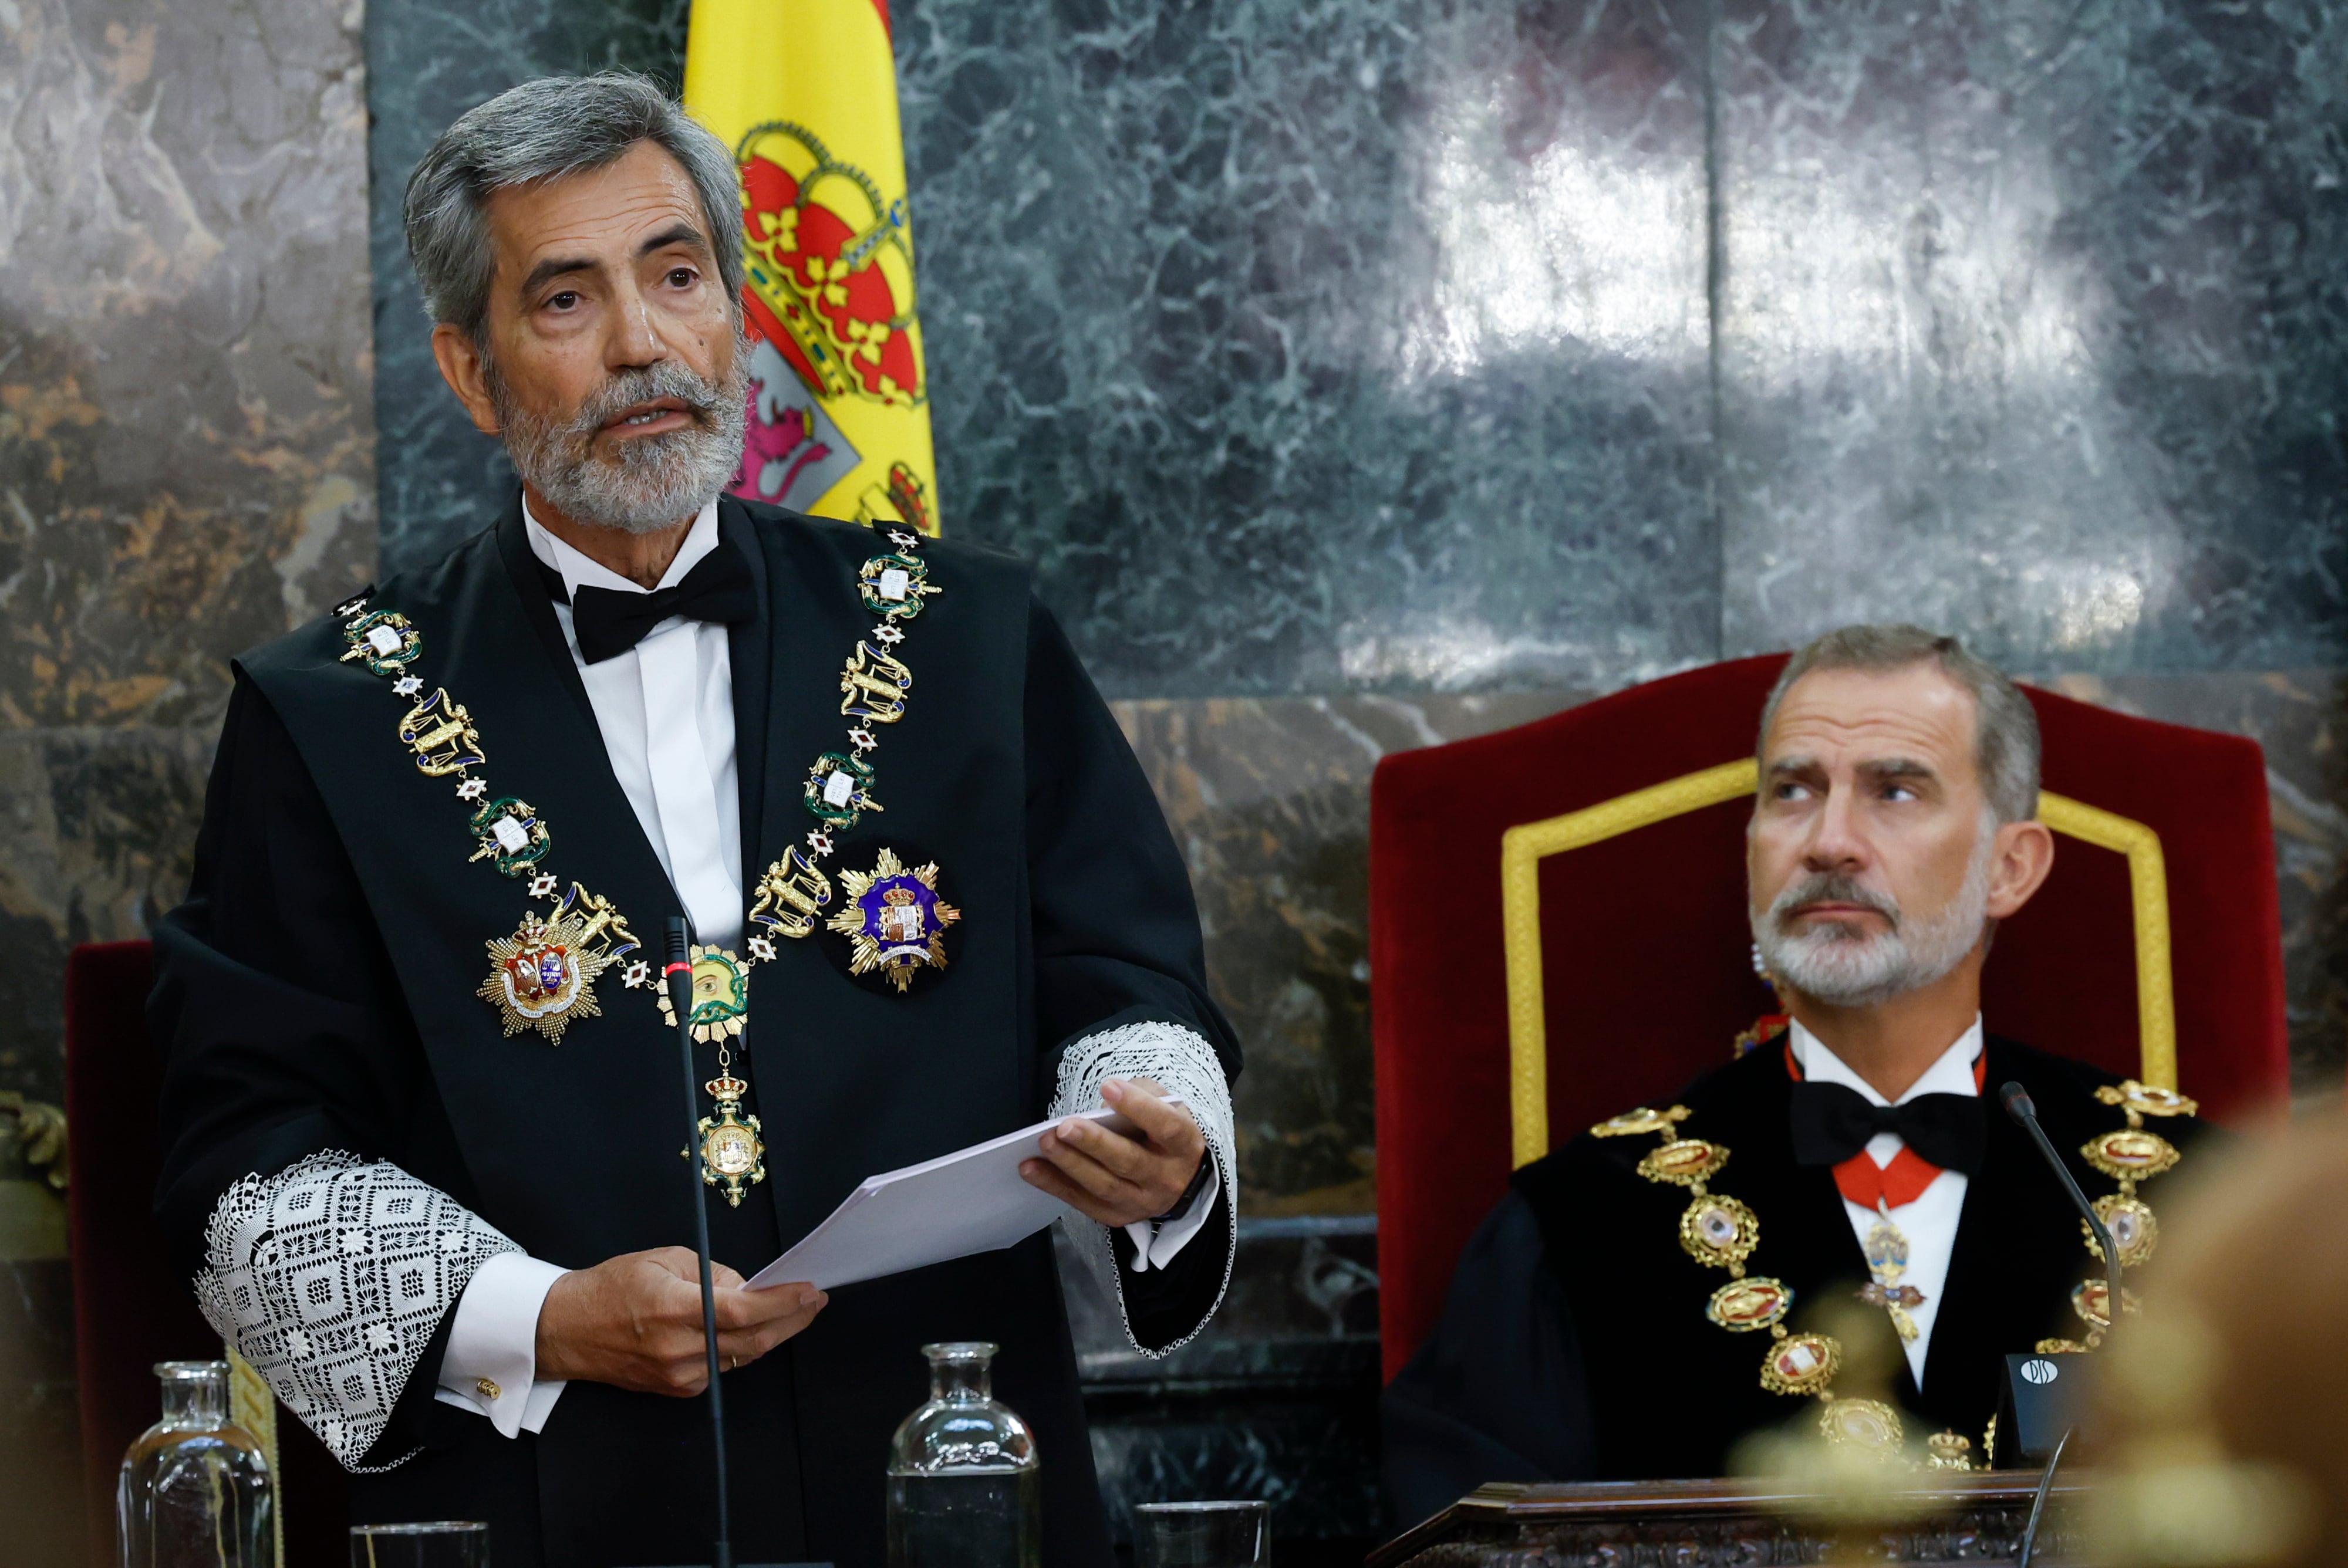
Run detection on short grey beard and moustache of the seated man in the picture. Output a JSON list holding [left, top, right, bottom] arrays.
[[1752, 819, 1996, 1007]]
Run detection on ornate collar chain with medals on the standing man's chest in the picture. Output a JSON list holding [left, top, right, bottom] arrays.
[[333, 528, 963, 1204]]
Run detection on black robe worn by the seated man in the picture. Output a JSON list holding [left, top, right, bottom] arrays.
[[1383, 1035, 2202, 1521]]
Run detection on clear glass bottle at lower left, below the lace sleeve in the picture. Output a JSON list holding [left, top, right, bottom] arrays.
[[115, 1361, 277, 1568]]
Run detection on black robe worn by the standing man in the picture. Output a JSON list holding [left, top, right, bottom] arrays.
[[150, 498, 1240, 1568]]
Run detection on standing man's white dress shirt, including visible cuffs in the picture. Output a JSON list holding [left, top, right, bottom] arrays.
[[434, 500, 1221, 1437]]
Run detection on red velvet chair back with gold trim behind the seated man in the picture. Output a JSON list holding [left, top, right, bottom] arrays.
[[1369, 655, 2287, 1378]]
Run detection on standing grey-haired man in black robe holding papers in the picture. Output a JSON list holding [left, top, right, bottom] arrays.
[[150, 75, 1240, 1568]]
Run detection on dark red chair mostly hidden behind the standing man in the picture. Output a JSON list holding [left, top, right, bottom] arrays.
[[66, 941, 350, 1568]]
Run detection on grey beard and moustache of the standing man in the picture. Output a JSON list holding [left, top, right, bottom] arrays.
[[481, 338, 749, 533]]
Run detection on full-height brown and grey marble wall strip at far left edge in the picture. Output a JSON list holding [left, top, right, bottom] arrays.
[[0, 0, 376, 1566]]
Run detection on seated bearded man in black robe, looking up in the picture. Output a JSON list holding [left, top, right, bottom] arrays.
[[1383, 627, 2198, 1519]]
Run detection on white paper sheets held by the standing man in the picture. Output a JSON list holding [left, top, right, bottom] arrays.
[[749, 1099, 1181, 1291]]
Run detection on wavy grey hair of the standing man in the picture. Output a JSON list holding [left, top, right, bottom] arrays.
[[406, 70, 742, 343]]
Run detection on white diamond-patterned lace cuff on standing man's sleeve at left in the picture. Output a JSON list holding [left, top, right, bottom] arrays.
[[195, 1150, 521, 1474]]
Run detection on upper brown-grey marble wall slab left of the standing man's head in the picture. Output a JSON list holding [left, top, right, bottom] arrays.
[[0, 0, 376, 730]]
